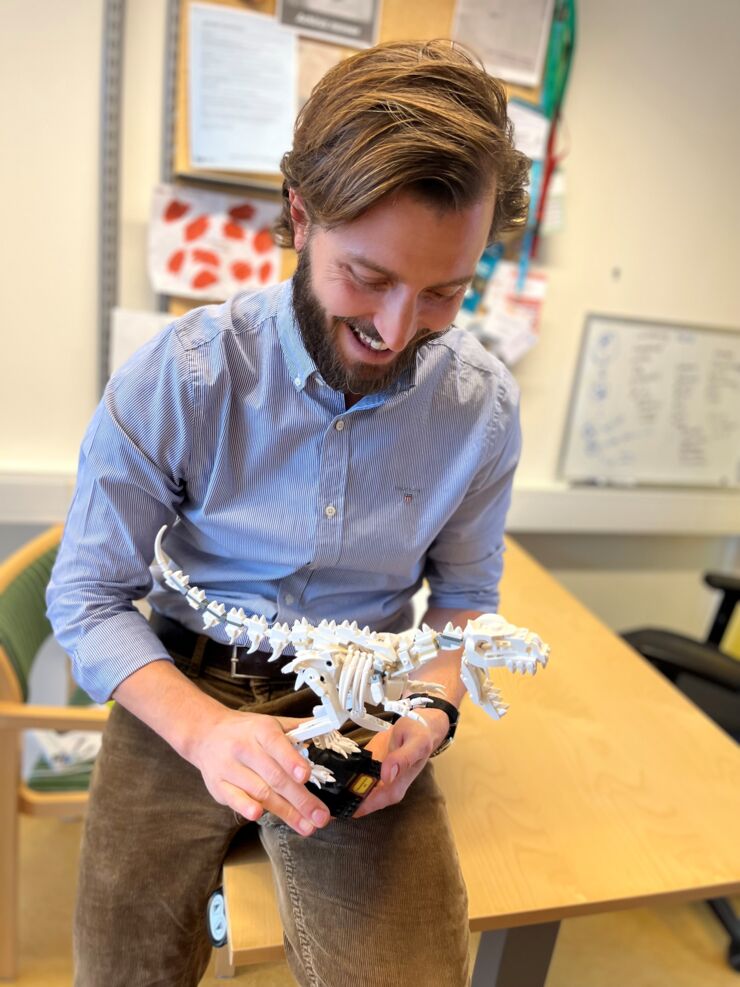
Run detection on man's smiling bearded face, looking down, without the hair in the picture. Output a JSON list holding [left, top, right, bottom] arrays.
[[288, 186, 495, 404]]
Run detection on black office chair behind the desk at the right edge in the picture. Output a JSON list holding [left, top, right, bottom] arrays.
[[622, 572, 740, 972]]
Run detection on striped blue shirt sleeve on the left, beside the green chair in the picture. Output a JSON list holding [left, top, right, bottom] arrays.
[[47, 328, 195, 702]]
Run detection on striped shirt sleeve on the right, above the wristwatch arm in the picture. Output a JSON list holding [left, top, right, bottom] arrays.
[[425, 378, 521, 613]]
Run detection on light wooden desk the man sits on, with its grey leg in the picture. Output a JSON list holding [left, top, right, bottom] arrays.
[[224, 541, 740, 987]]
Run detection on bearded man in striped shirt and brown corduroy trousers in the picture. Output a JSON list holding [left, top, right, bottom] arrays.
[[49, 42, 527, 987]]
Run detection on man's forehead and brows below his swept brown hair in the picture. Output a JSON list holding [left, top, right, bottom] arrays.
[[313, 193, 495, 287]]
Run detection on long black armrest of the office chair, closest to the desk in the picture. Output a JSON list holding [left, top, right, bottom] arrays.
[[622, 627, 740, 690]]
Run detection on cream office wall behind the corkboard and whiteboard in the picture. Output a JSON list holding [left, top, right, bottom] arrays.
[[0, 0, 740, 633]]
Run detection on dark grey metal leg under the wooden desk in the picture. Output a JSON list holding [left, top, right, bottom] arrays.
[[471, 922, 560, 987]]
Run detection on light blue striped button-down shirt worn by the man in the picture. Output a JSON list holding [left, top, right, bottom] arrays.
[[47, 282, 520, 701]]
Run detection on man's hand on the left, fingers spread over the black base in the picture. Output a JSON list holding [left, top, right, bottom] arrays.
[[189, 708, 330, 836]]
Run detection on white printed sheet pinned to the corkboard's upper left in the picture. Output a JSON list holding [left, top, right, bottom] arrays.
[[188, 3, 297, 174]]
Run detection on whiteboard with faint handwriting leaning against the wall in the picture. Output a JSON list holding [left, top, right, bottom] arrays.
[[561, 315, 740, 488]]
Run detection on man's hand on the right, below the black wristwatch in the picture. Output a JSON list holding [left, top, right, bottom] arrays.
[[354, 707, 450, 819]]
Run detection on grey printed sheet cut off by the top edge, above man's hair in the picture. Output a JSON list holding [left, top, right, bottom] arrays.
[[277, 0, 380, 48]]
